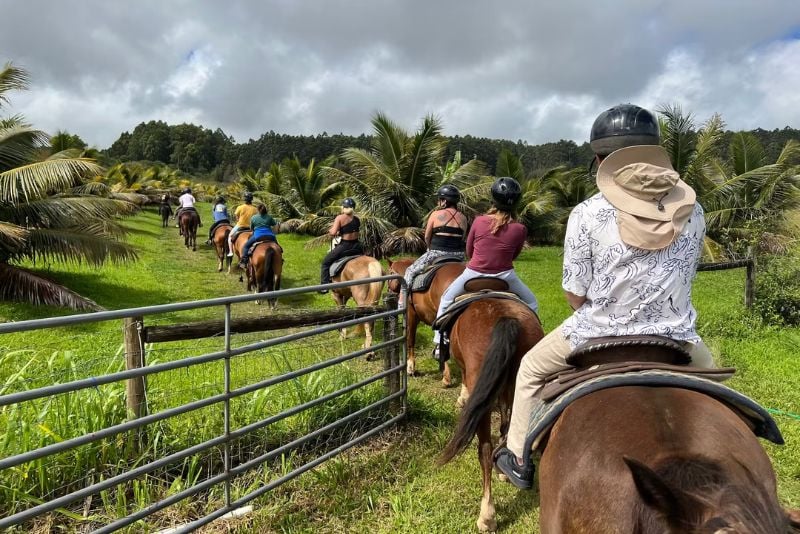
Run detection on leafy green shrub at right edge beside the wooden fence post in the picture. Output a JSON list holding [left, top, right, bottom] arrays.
[[754, 252, 800, 325]]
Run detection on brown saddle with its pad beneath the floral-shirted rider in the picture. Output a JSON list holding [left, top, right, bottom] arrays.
[[525, 336, 783, 468]]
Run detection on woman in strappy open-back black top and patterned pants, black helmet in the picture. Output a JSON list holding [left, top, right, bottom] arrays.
[[398, 184, 467, 308]]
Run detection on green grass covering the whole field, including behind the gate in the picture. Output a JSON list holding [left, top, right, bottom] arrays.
[[0, 206, 800, 533]]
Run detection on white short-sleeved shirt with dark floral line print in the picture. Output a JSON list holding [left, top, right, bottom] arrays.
[[561, 193, 706, 348]]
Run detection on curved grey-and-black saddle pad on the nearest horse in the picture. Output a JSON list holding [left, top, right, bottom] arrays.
[[524, 370, 784, 461]]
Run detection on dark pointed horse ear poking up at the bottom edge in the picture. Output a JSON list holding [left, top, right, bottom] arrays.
[[622, 456, 705, 532]]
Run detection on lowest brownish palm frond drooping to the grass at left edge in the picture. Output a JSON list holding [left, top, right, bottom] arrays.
[[0, 263, 103, 311]]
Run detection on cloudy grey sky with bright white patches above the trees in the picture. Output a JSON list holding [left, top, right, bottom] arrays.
[[0, 0, 800, 148]]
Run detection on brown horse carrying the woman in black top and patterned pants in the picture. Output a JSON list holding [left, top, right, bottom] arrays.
[[389, 258, 465, 387]]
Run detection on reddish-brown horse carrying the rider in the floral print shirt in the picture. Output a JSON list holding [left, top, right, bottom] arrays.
[[539, 386, 789, 534]]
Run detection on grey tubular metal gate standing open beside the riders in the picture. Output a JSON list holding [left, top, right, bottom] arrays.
[[0, 275, 407, 532]]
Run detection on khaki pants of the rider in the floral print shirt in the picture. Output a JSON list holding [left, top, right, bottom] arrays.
[[507, 324, 715, 458]]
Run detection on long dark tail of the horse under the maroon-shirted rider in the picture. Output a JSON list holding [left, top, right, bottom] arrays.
[[437, 317, 521, 465]]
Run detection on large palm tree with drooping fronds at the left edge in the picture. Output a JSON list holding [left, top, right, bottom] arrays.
[[0, 64, 136, 310]]
